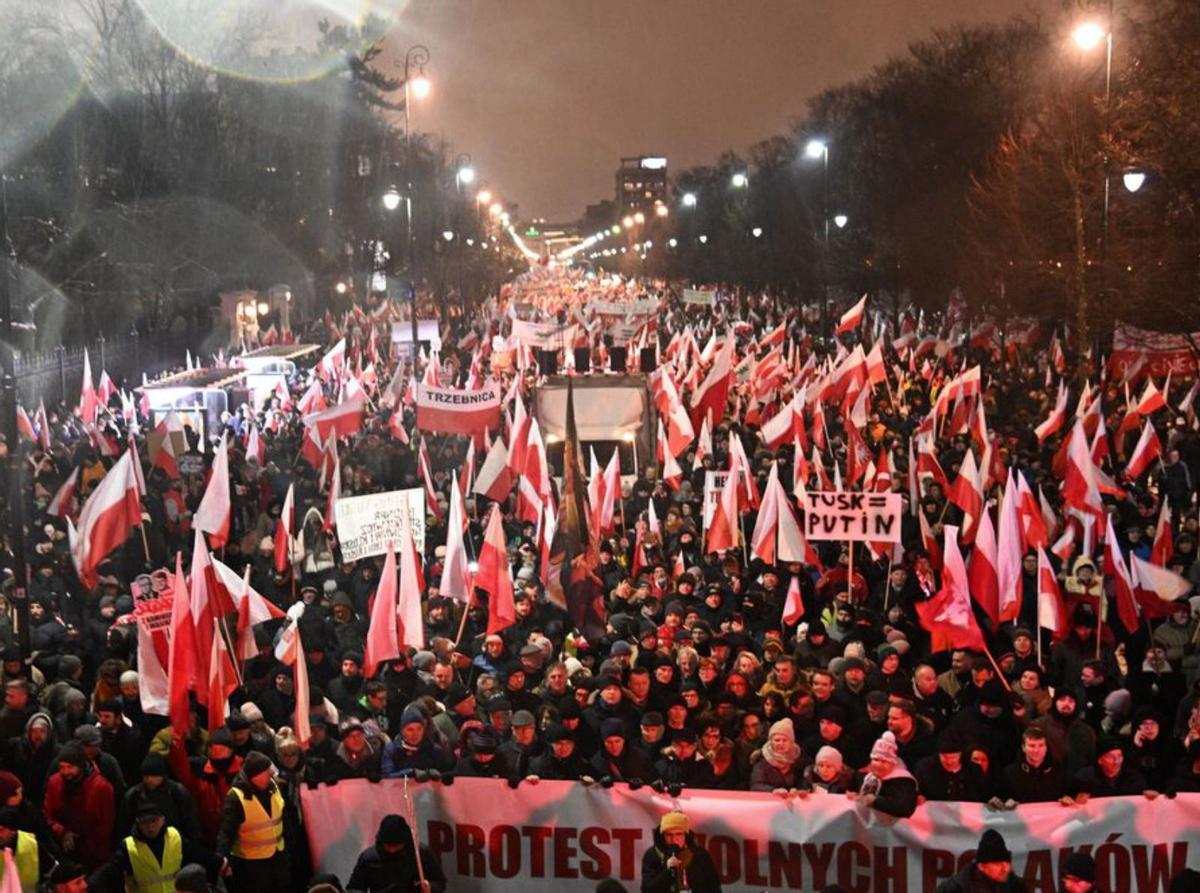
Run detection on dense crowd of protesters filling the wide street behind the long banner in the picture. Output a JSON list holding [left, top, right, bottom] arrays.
[[0, 274, 1200, 893]]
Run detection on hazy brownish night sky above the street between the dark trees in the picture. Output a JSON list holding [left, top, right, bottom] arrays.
[[389, 0, 1060, 221]]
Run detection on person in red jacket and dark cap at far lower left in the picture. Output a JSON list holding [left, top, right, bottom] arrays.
[[46, 742, 116, 870]]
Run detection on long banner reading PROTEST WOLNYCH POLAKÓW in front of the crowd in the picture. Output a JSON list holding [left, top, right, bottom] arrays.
[[300, 778, 1200, 893]]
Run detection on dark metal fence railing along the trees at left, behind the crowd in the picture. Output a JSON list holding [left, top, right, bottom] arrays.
[[16, 331, 187, 408]]
